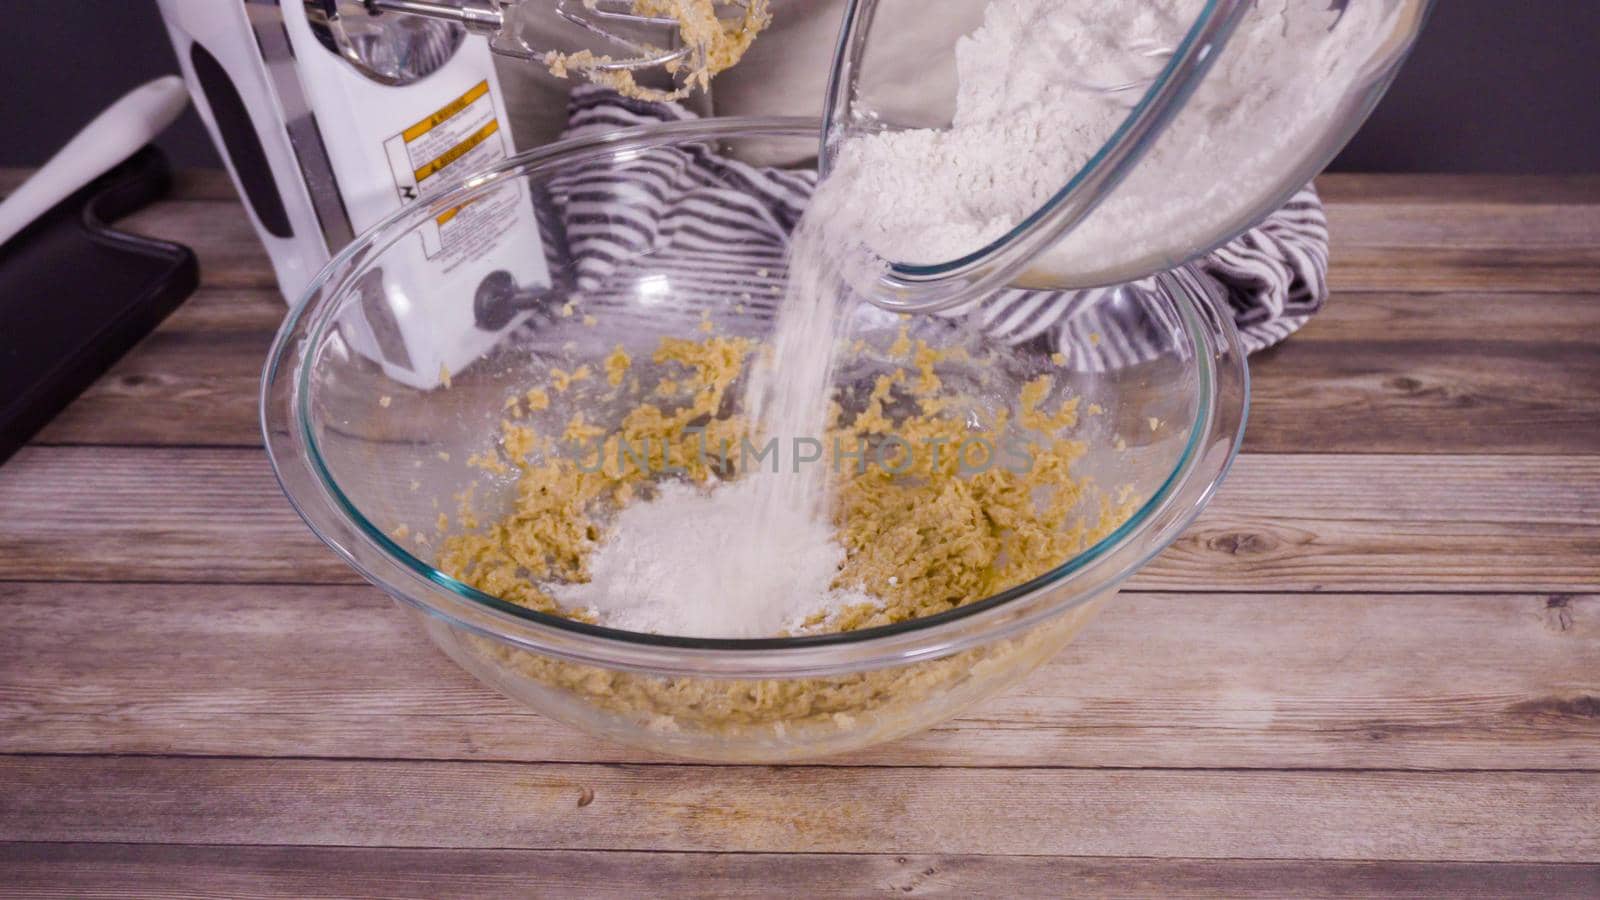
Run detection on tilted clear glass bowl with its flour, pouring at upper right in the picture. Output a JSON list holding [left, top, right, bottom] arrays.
[[822, 0, 1432, 311]]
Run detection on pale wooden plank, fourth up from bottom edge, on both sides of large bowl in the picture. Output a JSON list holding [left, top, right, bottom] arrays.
[[0, 447, 1600, 593]]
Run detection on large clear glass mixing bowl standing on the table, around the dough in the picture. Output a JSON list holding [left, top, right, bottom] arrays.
[[261, 119, 1248, 762]]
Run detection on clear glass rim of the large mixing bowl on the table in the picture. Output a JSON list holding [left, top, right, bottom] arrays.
[[259, 117, 1250, 677]]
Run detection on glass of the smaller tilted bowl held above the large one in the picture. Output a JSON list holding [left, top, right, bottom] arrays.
[[822, 0, 1432, 304]]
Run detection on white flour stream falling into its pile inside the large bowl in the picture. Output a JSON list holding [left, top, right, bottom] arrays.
[[555, 176, 875, 637]]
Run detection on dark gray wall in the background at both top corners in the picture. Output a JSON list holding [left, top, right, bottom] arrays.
[[0, 0, 1600, 173]]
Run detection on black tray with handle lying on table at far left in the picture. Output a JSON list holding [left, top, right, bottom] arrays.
[[0, 147, 200, 463]]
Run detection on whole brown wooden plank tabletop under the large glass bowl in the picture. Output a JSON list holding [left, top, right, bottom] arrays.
[[0, 171, 1600, 897]]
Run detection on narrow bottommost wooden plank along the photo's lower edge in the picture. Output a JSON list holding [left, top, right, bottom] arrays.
[[0, 844, 1600, 900]]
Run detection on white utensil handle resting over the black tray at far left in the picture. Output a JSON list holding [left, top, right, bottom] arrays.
[[0, 75, 189, 245]]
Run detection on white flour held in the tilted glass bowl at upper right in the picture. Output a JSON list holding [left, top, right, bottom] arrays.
[[830, 0, 1402, 283]]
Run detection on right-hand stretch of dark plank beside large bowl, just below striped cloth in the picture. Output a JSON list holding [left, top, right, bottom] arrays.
[[1245, 295, 1600, 453]]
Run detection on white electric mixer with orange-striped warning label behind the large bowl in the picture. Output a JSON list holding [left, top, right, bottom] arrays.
[[158, 0, 566, 388]]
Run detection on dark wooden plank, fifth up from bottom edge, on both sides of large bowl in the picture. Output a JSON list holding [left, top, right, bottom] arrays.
[[21, 290, 1600, 453]]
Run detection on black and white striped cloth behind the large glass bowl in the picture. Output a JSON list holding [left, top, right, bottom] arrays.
[[531, 86, 1328, 360]]
